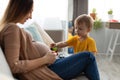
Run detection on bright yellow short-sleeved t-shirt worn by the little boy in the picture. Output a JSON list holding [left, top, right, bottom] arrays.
[[67, 35, 97, 53]]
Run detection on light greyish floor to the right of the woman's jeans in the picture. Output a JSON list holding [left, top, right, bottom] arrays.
[[75, 55, 120, 80]]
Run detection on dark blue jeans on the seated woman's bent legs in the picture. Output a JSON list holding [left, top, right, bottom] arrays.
[[49, 52, 100, 80]]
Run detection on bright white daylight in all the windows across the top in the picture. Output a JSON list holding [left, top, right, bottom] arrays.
[[0, 0, 120, 21]]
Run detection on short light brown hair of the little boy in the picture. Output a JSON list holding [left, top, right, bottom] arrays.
[[75, 14, 93, 29]]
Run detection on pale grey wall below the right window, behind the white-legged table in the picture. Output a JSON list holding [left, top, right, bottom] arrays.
[[90, 22, 120, 54]]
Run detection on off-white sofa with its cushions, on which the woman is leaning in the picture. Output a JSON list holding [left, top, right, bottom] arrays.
[[0, 22, 88, 80]]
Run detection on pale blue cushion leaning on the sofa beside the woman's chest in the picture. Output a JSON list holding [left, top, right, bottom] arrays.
[[25, 24, 44, 42]]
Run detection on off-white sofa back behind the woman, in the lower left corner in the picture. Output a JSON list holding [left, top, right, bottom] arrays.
[[0, 47, 14, 80]]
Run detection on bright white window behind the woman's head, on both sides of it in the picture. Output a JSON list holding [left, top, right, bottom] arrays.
[[0, 0, 68, 20]]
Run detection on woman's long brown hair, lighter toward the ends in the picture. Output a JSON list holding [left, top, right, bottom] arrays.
[[0, 0, 33, 25]]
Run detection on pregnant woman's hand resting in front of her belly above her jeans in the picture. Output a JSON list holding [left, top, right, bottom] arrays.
[[44, 51, 57, 65]]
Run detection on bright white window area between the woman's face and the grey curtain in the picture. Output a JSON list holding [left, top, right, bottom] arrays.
[[33, 0, 68, 27]]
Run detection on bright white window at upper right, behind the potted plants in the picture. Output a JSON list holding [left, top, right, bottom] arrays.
[[89, 0, 120, 21]]
